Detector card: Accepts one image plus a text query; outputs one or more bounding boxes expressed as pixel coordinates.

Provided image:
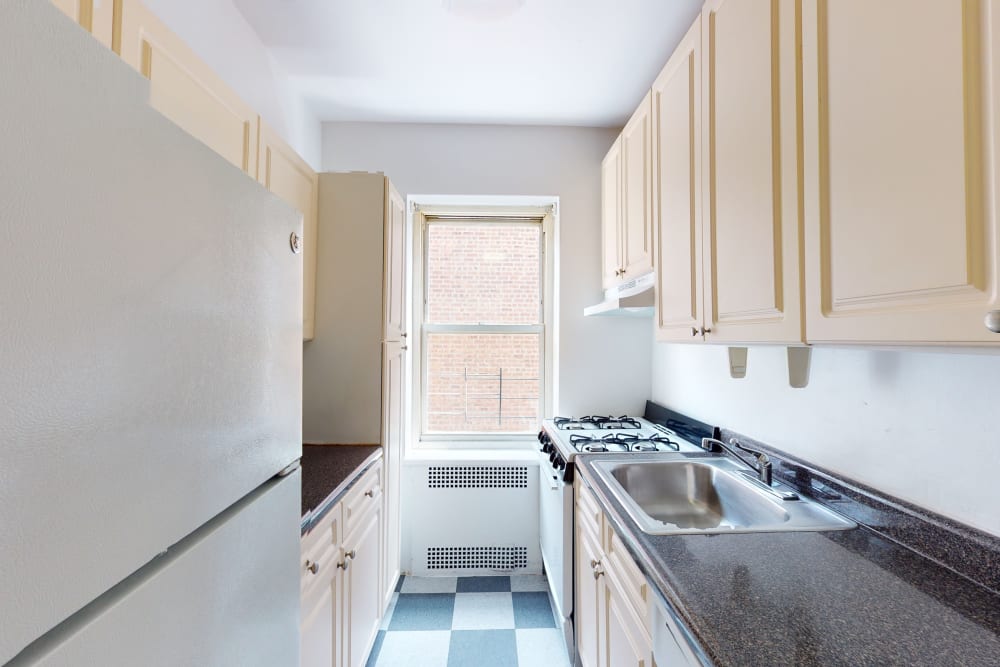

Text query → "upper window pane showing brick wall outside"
[427,222,541,324]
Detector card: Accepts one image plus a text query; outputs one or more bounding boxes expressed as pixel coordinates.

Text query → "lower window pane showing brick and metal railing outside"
[426,333,542,433]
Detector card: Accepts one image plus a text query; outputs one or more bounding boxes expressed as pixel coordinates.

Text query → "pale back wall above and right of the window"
[318,123,652,415]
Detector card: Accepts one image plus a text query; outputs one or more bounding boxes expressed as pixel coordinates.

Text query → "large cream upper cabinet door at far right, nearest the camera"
[802,0,1000,344]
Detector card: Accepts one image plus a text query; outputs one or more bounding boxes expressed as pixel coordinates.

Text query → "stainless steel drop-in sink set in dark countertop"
[593,455,857,535]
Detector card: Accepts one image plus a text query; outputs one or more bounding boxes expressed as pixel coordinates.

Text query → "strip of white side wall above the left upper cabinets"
[143,0,322,170]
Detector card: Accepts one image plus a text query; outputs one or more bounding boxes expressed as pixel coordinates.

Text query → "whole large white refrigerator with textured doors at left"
[0,0,309,667]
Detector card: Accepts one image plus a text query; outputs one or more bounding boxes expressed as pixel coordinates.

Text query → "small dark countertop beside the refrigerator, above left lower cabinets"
[302,445,382,533]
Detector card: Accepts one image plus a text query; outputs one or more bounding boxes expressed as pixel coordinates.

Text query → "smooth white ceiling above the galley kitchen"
[233,0,702,127]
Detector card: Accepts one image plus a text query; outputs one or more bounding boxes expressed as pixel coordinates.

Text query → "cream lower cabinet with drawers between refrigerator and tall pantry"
[301,466,385,667]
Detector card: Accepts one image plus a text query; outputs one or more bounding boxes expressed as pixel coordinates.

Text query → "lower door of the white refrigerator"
[8,472,301,667]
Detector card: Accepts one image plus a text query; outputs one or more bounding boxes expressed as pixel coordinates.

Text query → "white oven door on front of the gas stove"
[538,452,573,655]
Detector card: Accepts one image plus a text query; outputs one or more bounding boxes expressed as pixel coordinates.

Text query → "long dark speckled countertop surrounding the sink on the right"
[576,455,1000,667]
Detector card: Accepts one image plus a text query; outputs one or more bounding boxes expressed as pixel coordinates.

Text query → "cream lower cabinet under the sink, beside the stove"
[574,478,652,667]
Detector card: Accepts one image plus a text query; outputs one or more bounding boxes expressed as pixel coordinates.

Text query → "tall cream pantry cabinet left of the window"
[303,172,409,603]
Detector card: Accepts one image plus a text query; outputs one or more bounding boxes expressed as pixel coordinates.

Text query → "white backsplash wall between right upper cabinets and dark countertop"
[652,343,1000,535]
